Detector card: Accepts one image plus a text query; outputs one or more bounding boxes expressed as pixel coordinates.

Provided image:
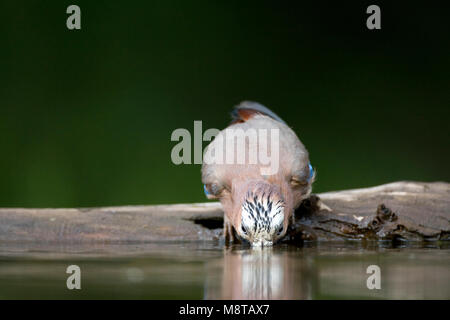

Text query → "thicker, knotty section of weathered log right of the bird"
[292,182,450,241]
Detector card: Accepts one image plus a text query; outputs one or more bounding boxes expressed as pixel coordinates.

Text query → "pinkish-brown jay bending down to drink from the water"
[201,101,316,247]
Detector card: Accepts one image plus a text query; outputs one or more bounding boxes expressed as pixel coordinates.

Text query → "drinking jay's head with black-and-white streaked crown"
[234,181,289,246]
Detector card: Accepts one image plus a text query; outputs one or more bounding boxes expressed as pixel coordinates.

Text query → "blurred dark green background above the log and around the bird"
[0,0,450,207]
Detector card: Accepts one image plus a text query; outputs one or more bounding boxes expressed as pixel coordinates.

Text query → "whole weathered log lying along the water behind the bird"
[0,182,450,242]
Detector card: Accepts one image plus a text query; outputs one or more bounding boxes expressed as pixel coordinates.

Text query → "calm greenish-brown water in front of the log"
[0,242,450,299]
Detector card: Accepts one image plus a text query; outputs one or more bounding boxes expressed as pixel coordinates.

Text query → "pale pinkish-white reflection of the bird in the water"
[205,248,317,300]
